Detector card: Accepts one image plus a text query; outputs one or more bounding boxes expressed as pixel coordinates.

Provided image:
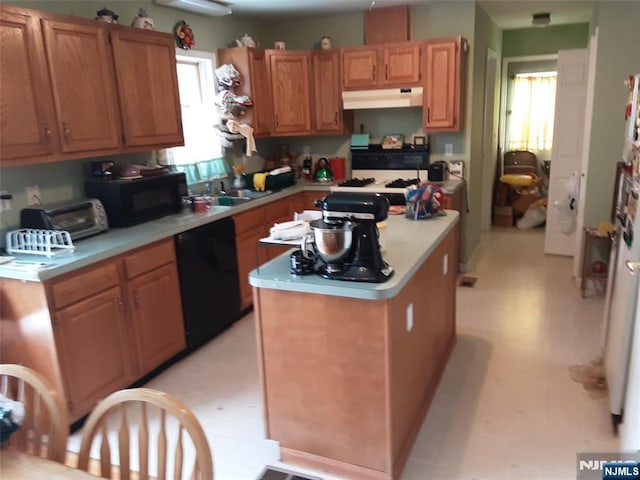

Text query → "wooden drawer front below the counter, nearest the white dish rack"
[50,262,120,310]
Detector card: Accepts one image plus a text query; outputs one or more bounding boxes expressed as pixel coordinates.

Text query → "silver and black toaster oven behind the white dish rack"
[20,198,109,240]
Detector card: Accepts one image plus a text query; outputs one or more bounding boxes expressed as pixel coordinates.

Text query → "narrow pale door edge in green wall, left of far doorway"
[480,48,498,232]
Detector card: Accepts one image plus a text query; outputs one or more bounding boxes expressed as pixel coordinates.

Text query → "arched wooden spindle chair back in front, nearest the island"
[78,388,213,480]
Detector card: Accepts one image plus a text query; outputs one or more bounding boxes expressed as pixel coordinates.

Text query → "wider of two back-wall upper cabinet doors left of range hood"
[268,50,311,135]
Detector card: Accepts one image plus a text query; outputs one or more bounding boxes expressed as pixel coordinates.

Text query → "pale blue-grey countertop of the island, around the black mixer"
[249,210,459,300]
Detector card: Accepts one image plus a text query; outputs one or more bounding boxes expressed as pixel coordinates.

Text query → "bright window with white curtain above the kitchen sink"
[162,51,227,183]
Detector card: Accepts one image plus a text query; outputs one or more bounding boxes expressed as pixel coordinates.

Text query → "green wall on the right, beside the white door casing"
[585,1,640,225]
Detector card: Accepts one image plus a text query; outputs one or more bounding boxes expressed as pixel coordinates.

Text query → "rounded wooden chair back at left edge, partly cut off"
[0,364,69,463]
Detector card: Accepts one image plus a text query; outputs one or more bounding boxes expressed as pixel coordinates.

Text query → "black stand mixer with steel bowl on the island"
[303,192,393,283]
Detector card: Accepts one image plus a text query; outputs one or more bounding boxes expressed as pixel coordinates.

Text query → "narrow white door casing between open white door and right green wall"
[573,27,598,278]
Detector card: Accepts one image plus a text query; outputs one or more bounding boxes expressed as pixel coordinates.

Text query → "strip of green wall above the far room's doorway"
[502,23,589,57]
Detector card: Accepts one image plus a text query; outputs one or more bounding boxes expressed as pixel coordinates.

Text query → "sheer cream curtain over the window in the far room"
[507,72,557,158]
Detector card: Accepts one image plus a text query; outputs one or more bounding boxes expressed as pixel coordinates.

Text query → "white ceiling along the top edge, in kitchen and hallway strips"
[218,0,595,29]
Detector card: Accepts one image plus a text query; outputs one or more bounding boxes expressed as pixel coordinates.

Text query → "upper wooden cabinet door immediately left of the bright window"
[111,29,184,146]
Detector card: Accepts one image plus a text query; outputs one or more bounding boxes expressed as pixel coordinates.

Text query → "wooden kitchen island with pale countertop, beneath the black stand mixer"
[249,210,459,479]
